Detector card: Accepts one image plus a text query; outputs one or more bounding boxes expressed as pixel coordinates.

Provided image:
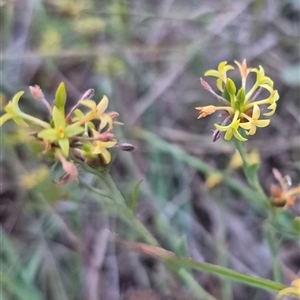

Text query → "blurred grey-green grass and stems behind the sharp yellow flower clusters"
[0,0,300,300]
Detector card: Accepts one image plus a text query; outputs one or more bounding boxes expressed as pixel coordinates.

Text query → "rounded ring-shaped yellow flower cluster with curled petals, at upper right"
[196,60,279,141]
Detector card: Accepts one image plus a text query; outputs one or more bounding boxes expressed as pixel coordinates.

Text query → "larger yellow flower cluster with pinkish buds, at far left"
[0,83,124,182]
